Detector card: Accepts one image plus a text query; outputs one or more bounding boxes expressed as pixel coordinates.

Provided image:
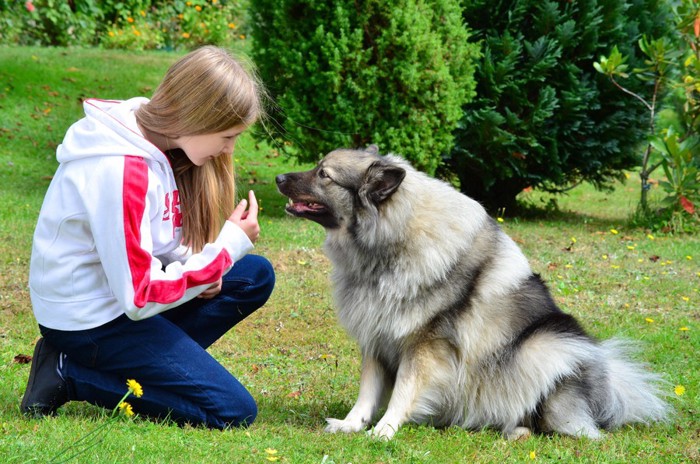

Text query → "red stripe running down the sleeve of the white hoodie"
[123,156,231,308]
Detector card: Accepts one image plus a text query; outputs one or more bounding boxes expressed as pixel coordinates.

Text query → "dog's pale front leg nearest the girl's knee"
[325,357,386,433]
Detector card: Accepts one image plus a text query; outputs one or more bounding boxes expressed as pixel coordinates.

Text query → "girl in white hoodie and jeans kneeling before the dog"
[21,47,274,429]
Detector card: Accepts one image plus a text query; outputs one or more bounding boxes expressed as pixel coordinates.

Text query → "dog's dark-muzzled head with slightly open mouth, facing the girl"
[276,145,406,229]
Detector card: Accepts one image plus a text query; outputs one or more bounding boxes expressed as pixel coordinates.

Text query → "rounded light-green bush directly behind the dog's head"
[250,0,478,172]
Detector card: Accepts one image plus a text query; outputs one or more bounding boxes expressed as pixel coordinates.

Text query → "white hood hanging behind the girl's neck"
[56,97,168,163]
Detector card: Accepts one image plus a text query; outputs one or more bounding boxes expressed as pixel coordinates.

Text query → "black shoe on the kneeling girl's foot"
[21,338,68,418]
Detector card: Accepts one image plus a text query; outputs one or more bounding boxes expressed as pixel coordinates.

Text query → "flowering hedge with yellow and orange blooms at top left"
[0,0,248,50]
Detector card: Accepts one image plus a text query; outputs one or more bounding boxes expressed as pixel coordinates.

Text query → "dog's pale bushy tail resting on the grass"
[598,339,671,429]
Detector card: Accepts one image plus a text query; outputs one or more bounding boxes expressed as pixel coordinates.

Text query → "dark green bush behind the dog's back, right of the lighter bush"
[448,0,670,210]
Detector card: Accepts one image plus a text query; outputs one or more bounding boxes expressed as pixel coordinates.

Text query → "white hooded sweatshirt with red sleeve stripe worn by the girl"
[29,98,253,330]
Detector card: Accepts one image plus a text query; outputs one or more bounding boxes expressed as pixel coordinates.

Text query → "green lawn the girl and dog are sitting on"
[0,47,700,463]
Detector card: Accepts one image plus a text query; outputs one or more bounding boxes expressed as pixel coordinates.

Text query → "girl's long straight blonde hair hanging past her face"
[136,46,263,252]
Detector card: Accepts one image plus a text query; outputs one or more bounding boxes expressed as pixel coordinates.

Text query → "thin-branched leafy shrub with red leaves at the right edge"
[594,0,700,232]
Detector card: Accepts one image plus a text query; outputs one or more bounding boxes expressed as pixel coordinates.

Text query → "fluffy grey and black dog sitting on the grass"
[277,146,669,439]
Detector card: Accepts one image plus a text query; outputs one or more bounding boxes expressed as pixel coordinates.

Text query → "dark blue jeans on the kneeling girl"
[39,255,275,429]
